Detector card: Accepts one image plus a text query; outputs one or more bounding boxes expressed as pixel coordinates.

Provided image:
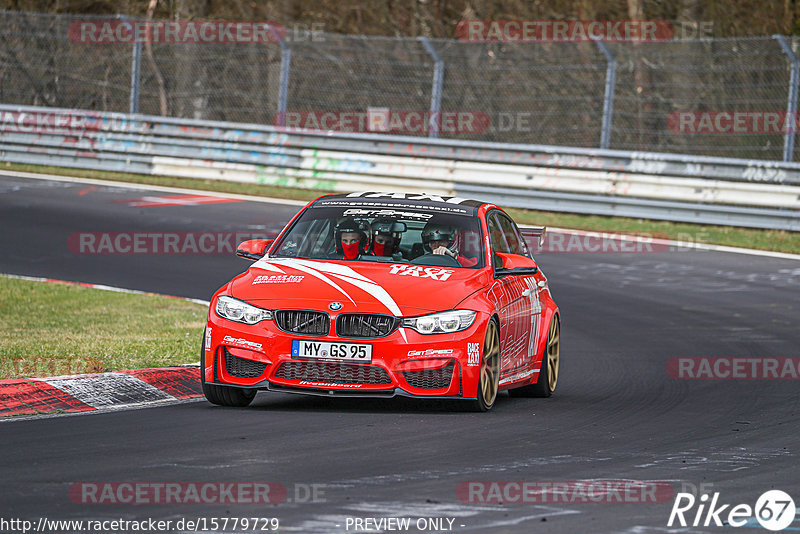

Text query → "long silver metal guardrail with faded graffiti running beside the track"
[0,105,800,231]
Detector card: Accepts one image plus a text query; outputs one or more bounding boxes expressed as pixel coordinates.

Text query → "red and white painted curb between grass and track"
[0,366,203,417]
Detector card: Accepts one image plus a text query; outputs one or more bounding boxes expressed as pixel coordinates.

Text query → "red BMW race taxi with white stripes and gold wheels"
[201,192,560,411]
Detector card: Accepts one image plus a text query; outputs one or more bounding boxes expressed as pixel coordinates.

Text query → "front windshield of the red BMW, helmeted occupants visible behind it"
[271,206,485,269]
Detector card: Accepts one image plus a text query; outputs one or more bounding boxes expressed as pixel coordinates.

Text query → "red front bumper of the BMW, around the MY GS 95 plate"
[202,311,486,398]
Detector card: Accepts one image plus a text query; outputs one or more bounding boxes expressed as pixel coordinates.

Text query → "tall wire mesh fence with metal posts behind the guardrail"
[0,11,800,161]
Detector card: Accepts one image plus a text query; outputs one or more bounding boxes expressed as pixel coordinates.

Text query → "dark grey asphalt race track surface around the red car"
[0,176,800,533]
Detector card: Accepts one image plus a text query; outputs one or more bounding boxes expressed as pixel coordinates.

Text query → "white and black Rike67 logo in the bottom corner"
[667,490,796,532]
